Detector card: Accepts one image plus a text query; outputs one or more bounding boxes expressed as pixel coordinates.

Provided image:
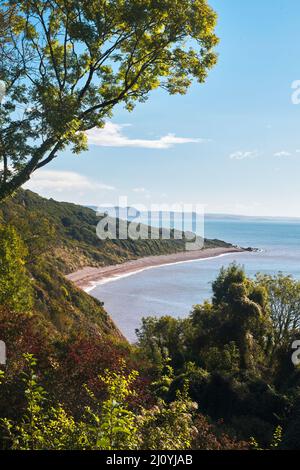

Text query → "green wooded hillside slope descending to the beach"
[0,190,232,337]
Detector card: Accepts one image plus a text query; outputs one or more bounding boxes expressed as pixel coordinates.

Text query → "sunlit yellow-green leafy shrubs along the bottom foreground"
[0,354,223,450]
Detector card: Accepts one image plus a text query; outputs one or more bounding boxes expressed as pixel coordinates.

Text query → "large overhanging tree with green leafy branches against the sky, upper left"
[0,0,218,200]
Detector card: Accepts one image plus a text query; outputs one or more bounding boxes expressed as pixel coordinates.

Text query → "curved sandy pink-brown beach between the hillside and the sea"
[66,247,245,292]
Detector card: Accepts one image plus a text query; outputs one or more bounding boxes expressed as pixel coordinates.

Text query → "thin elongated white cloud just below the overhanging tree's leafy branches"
[87,122,207,149]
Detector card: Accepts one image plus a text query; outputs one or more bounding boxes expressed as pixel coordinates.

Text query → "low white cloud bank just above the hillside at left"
[24,170,115,192]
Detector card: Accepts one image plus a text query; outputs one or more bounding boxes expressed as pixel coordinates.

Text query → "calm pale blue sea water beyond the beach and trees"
[91,218,300,341]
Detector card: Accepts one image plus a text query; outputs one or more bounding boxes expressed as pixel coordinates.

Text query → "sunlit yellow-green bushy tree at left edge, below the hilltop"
[0,225,32,312]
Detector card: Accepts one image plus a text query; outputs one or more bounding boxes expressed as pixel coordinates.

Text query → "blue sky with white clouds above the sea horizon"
[26,0,300,217]
